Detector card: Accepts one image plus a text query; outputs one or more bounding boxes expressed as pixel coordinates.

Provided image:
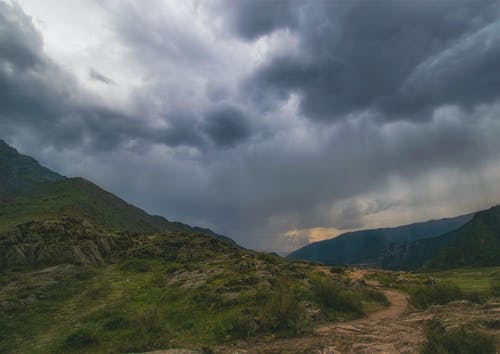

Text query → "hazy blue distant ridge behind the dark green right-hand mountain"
[288,215,472,266]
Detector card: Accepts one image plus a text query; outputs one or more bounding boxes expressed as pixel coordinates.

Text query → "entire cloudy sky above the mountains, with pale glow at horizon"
[0,0,500,252]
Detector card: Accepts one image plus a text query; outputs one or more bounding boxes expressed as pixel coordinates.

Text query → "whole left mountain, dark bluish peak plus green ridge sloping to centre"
[0,142,234,242]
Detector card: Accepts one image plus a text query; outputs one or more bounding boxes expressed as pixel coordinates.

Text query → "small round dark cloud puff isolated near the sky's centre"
[205,106,251,148]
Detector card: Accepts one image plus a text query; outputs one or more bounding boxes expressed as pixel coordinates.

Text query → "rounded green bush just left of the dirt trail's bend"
[311,279,363,315]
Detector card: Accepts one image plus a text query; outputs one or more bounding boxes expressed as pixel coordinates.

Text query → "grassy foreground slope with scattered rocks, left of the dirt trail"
[0,223,386,353]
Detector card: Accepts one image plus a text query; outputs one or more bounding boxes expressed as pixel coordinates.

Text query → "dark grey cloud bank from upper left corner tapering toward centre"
[0,2,209,152]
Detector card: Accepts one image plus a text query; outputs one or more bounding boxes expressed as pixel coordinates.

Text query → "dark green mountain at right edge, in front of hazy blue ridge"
[382,206,500,269]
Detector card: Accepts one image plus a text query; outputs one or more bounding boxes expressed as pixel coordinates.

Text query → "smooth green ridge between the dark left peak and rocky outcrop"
[0,178,232,242]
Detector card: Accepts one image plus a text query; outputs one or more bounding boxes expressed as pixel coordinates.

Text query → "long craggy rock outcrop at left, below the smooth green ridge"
[0,217,238,269]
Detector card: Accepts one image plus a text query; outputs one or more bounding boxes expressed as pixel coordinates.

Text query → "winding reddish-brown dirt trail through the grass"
[215,269,424,354]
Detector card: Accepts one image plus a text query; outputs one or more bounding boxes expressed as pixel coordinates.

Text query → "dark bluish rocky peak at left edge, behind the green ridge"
[0,139,64,199]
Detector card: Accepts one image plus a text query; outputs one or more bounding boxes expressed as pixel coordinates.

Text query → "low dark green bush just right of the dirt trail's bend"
[409,283,465,309]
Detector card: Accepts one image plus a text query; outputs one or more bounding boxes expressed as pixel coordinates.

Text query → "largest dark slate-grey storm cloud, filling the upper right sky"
[240,0,500,121]
